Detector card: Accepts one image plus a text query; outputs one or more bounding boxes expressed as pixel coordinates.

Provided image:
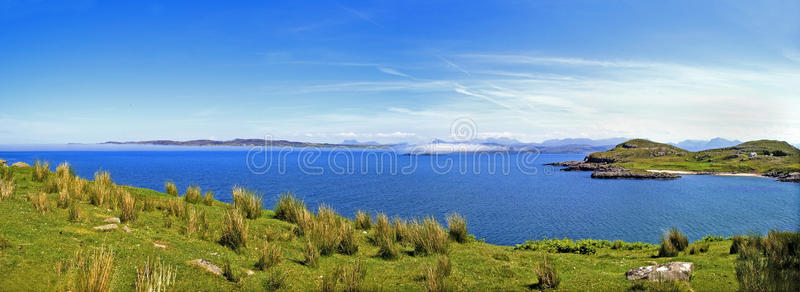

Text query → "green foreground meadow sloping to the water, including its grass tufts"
[0,164,798,291]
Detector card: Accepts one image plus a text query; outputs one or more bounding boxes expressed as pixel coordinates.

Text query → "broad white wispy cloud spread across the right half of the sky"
[274,54,800,141]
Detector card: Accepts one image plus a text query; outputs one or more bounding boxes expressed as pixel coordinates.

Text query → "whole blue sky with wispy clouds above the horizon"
[0,0,800,144]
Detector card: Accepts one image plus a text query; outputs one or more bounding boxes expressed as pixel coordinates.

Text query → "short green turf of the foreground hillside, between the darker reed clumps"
[0,166,768,291]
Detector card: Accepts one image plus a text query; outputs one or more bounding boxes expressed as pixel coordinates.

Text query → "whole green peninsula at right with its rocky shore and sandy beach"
[549,139,800,182]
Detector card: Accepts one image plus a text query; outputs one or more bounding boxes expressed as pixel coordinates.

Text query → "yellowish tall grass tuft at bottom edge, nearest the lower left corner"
[75,247,114,292]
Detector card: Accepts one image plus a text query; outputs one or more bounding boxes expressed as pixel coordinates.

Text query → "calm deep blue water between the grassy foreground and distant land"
[0,147,800,245]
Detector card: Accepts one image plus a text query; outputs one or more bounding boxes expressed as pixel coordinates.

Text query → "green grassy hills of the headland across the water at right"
[587,139,800,173]
